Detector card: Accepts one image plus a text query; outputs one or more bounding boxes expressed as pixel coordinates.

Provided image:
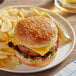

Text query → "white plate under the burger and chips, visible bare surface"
[0,6,75,73]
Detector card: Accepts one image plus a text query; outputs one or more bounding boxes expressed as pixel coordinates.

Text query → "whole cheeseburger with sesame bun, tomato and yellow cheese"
[9,16,59,67]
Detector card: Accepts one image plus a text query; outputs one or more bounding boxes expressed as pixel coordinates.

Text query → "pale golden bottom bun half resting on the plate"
[15,51,56,67]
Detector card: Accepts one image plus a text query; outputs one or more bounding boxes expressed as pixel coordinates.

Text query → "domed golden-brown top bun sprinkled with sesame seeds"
[14,16,58,48]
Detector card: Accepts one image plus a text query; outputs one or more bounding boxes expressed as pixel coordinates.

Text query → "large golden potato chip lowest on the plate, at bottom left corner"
[0,56,20,69]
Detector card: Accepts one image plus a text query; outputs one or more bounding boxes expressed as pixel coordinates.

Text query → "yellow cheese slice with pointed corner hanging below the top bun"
[29,40,57,56]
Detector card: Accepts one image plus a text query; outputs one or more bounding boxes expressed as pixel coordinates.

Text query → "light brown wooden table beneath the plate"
[0,0,76,76]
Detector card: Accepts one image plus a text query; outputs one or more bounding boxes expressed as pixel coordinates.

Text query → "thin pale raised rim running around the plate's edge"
[0,5,75,73]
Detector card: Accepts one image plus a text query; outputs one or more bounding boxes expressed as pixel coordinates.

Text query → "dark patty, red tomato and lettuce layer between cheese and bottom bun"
[8,40,59,59]
